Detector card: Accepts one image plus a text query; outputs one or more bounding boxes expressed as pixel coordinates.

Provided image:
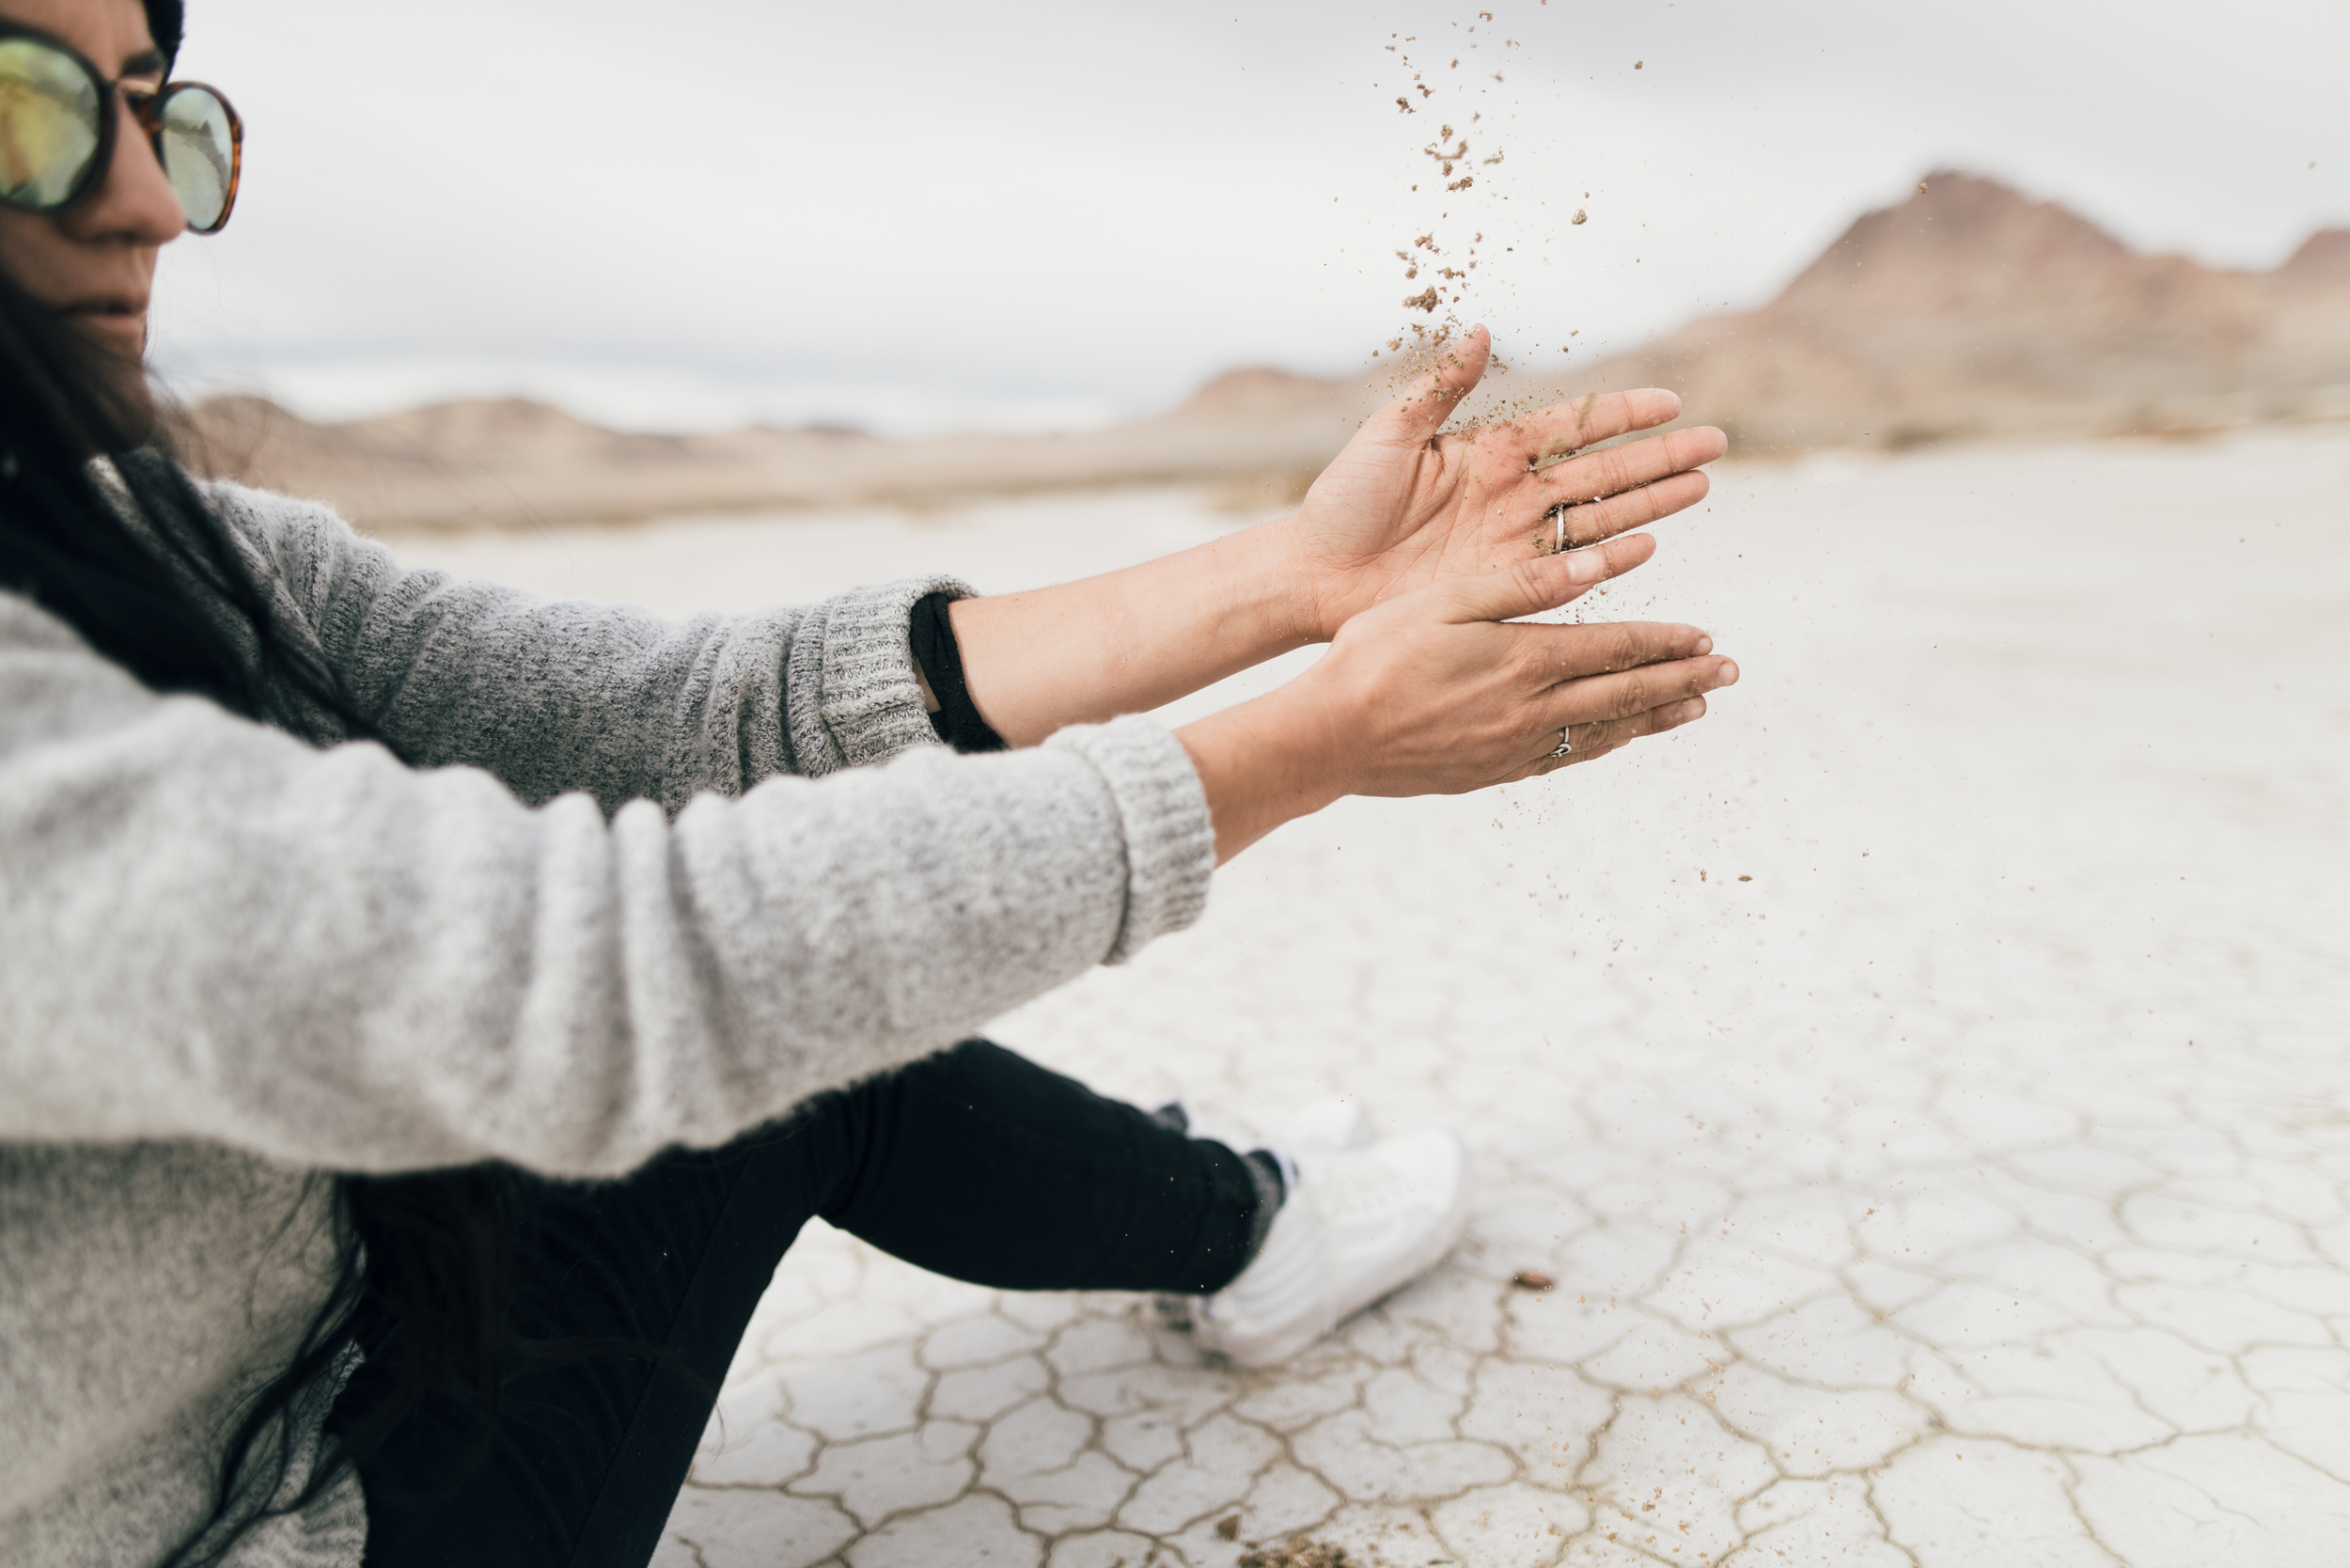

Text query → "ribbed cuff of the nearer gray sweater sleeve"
[1046,717,1215,964]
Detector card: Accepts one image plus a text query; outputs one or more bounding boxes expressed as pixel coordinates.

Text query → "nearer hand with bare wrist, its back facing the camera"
[1178,534,1739,860]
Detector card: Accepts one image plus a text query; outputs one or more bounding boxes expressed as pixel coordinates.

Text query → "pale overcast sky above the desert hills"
[155,0,2350,431]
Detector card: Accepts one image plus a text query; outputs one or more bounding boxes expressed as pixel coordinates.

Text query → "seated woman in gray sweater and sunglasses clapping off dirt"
[0,0,1737,1568]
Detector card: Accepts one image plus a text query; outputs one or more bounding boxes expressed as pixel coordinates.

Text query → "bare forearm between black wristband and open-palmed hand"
[948,520,1316,752]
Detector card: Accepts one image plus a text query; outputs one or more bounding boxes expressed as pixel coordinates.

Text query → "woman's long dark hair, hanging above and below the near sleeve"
[0,0,545,1563]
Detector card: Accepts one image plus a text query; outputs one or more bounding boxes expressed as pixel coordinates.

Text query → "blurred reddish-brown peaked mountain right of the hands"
[1591,172,2350,456]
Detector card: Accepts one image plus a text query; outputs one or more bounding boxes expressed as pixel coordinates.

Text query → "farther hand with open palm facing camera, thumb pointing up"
[1281,327,1730,639]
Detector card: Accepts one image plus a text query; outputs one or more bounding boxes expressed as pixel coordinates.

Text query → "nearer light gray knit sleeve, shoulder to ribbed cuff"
[0,595,1213,1175]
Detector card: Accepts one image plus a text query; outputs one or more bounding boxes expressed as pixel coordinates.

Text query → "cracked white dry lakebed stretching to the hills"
[395,431,2350,1568]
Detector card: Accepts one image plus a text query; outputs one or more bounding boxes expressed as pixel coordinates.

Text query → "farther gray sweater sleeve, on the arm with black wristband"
[205,484,971,813]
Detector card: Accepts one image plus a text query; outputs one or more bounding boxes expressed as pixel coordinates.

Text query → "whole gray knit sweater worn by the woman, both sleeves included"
[0,487,1213,1568]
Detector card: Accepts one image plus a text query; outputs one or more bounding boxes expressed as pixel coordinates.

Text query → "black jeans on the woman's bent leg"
[337,1039,1262,1568]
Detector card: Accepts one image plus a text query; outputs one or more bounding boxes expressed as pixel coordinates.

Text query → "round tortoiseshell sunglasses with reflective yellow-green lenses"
[0,24,244,235]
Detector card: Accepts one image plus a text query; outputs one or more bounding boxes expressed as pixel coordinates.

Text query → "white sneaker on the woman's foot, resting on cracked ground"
[1192,1128,1469,1366]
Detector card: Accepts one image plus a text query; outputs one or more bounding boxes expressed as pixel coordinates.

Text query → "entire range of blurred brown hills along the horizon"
[186,172,2350,529]
